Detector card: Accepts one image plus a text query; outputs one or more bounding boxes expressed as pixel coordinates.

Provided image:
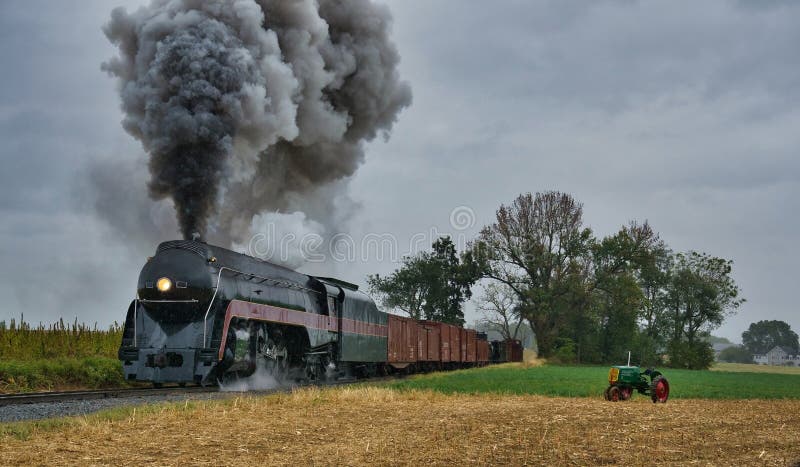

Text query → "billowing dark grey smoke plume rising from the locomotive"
[103,0,411,244]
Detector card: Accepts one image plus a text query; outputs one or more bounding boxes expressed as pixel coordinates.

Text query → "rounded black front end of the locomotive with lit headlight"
[119,241,216,385]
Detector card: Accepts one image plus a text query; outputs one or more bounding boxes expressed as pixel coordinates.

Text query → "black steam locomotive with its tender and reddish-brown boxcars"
[119,240,491,385]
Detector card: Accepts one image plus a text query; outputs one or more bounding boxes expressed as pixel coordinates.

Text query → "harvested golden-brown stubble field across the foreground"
[0,388,800,466]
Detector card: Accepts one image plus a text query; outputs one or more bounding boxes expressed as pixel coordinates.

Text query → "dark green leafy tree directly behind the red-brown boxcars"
[367,237,476,326]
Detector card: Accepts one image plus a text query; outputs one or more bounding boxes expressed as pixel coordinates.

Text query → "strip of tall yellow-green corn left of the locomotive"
[0,317,122,361]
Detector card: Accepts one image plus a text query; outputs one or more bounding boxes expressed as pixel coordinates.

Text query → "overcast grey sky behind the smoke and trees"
[0,0,800,341]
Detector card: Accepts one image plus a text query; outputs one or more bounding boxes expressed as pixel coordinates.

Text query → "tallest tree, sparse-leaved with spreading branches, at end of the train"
[466,191,592,356]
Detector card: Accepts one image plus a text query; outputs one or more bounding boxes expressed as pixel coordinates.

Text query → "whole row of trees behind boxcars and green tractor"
[367,191,744,368]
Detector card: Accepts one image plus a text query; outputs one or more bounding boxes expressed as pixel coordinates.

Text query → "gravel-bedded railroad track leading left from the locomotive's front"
[0,386,219,407]
